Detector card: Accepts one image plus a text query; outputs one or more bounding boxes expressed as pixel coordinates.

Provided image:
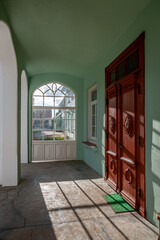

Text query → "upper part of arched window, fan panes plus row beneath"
[33,83,75,108]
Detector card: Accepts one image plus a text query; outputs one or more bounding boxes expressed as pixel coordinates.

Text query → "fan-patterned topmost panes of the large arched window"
[33,83,75,97]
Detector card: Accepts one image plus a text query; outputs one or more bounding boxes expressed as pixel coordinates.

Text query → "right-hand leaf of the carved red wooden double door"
[118,75,138,209]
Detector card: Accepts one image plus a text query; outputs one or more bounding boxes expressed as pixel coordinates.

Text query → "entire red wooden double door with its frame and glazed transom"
[105,34,145,216]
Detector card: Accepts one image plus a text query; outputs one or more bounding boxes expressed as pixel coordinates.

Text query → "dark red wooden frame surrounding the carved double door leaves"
[105,32,146,217]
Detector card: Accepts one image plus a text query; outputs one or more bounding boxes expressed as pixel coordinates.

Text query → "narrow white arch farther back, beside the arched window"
[21,70,28,163]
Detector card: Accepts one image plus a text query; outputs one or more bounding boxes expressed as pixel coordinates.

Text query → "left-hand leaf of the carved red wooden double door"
[106,86,117,190]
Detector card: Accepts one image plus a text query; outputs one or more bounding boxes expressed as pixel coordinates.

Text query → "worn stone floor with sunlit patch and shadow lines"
[0,161,158,240]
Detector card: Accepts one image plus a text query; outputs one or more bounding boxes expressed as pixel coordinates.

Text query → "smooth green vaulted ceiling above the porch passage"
[3,0,150,77]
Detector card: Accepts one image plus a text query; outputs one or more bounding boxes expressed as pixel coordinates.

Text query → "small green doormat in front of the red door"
[104,194,135,213]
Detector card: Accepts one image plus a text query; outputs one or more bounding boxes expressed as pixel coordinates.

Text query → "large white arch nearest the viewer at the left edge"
[0,21,18,186]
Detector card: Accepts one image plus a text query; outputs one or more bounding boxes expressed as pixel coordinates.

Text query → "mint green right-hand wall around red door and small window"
[84,0,160,225]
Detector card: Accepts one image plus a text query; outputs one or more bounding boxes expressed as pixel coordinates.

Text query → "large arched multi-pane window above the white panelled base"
[32,83,76,141]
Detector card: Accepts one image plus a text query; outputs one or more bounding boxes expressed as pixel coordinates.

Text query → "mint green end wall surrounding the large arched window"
[28,73,84,162]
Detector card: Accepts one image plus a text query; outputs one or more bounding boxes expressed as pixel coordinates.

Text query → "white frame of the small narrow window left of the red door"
[88,84,97,144]
